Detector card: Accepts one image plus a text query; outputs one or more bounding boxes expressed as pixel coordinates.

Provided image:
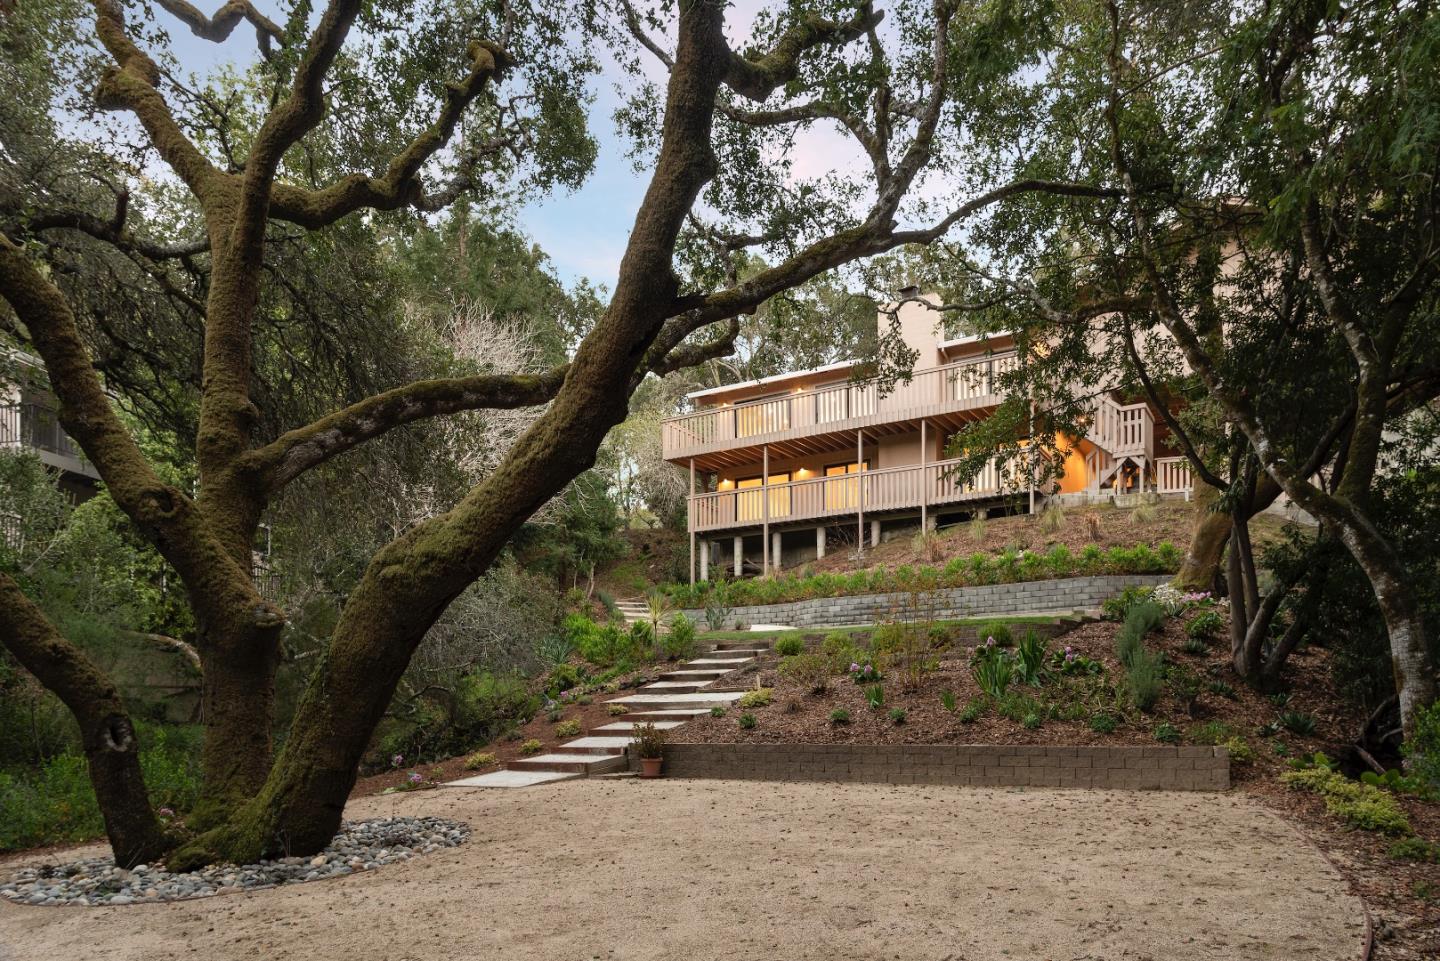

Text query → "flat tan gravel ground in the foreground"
[0,779,1364,961]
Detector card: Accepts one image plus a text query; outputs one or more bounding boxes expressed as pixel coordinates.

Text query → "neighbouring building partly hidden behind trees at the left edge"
[0,347,99,503]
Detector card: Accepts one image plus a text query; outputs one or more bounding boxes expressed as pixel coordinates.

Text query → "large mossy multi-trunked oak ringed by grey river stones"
[0,0,1096,869]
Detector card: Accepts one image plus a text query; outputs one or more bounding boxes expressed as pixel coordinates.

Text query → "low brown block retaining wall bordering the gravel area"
[653,743,1230,791]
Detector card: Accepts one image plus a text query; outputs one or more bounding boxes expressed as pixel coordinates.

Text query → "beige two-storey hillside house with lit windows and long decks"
[661,288,1191,581]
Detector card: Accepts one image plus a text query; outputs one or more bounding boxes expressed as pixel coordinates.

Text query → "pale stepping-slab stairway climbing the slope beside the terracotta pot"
[444,637,770,788]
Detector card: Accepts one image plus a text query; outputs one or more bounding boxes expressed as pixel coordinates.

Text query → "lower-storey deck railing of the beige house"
[690,458,1024,532]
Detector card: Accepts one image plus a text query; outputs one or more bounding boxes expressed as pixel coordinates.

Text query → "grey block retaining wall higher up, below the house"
[684,573,1171,627]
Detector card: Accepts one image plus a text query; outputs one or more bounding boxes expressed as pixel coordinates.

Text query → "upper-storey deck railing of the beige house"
[661,352,1020,457]
